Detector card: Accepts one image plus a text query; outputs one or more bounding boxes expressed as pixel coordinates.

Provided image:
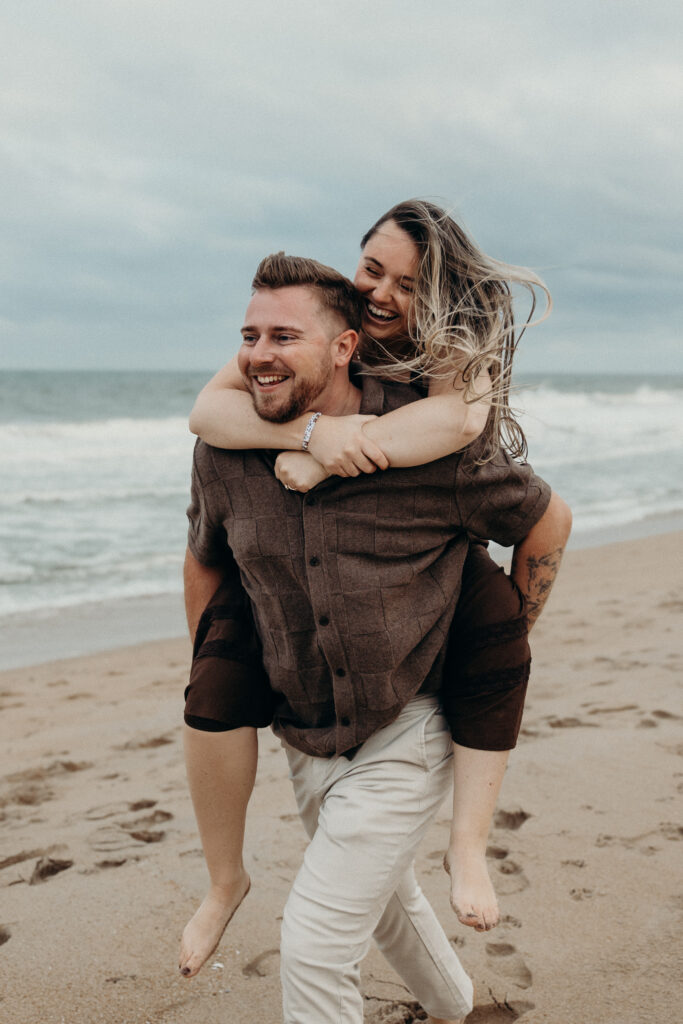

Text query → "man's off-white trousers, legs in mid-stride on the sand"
[281,696,472,1024]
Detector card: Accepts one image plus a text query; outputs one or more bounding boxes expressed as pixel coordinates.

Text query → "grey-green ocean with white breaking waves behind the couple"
[0,371,683,622]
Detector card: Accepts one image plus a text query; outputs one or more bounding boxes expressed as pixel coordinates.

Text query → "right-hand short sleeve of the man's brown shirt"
[456,450,551,547]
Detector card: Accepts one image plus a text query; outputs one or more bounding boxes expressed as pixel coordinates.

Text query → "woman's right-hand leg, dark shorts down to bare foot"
[442,544,530,931]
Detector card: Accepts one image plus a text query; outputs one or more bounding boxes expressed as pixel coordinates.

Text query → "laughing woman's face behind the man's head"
[353,220,420,342]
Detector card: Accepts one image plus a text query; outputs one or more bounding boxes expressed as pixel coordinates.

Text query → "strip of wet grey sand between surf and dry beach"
[0,514,683,671]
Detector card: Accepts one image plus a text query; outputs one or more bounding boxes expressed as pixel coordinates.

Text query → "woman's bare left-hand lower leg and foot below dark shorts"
[178,725,258,978]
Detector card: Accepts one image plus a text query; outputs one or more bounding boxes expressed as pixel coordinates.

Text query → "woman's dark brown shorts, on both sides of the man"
[185,544,530,751]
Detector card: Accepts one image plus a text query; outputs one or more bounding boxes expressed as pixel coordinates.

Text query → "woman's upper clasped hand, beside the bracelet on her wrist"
[305,415,389,477]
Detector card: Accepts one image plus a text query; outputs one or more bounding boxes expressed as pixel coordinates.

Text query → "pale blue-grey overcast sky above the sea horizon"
[0,0,683,373]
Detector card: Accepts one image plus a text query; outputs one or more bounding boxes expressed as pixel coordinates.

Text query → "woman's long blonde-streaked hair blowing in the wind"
[360,200,552,461]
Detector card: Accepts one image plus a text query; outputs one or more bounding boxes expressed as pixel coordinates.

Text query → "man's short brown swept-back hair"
[252,252,362,331]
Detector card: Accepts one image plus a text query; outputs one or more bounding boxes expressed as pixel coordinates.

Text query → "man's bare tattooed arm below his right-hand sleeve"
[510,492,571,629]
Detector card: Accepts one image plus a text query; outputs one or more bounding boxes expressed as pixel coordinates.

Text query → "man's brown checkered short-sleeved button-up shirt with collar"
[187,377,550,757]
